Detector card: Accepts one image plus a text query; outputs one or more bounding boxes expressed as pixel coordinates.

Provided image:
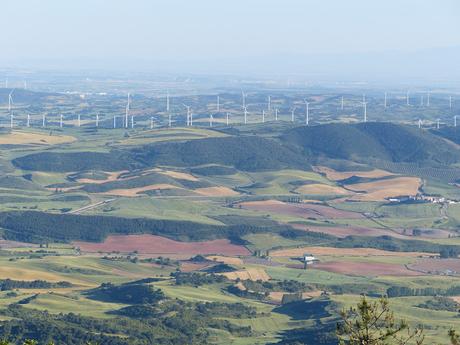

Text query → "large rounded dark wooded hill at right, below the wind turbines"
[282,122,460,165]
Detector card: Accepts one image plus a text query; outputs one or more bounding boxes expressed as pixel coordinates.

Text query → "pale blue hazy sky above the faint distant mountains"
[0,0,460,77]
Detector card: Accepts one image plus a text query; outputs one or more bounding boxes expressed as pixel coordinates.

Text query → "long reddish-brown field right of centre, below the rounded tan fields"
[239,200,364,219]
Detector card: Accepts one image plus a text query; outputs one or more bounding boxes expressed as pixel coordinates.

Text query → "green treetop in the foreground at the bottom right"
[337,297,424,345]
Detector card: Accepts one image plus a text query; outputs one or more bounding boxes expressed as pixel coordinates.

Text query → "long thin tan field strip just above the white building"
[270,247,433,258]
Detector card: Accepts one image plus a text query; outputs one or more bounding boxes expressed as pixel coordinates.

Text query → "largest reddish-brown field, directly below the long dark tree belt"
[73,235,250,256]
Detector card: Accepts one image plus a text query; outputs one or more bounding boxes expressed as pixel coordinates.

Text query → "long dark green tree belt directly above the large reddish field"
[0,211,289,243]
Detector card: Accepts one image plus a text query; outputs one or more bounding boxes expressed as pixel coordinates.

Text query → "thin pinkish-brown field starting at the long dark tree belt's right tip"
[291,224,407,239]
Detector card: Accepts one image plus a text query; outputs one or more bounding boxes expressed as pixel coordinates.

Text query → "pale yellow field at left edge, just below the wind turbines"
[0,131,77,145]
